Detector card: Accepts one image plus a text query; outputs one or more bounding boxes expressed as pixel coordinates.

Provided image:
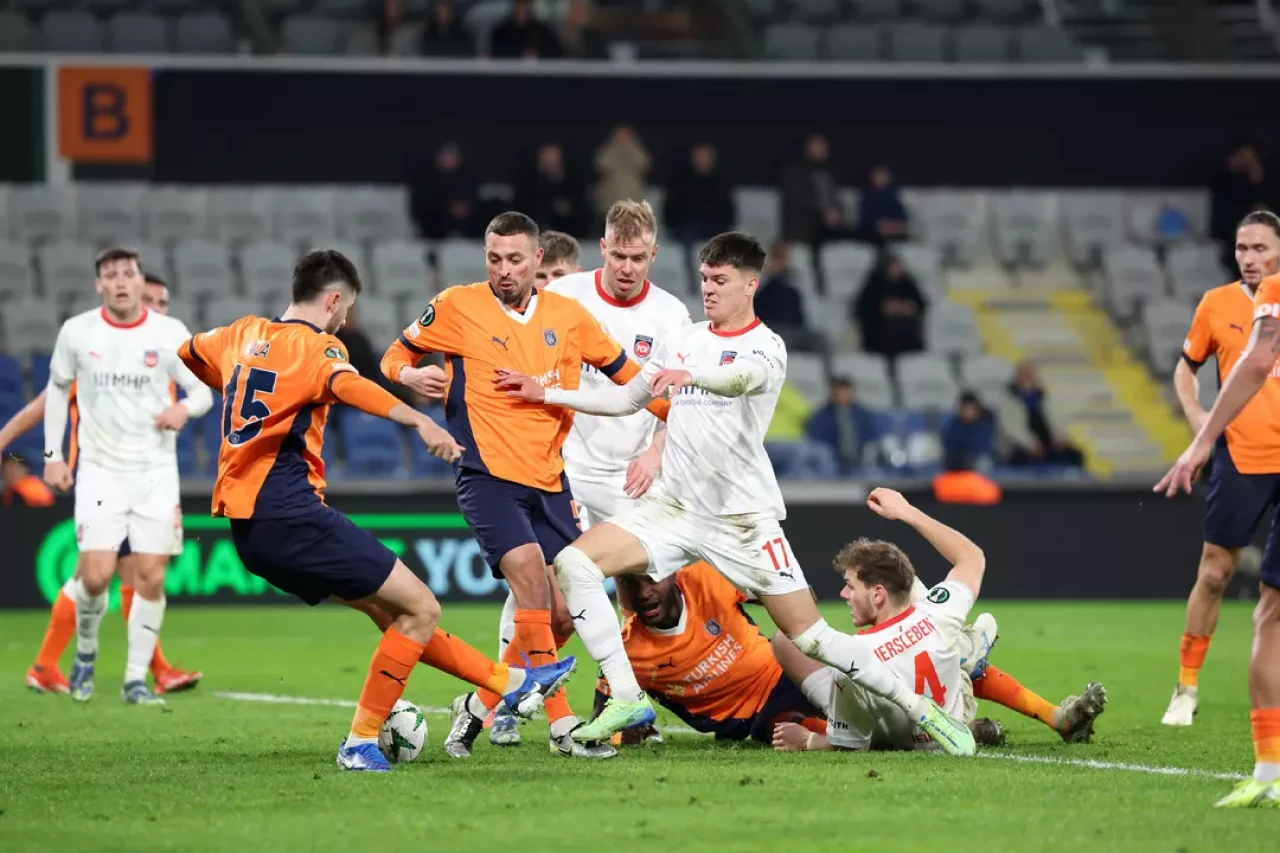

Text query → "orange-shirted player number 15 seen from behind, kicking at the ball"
[179,250,573,772]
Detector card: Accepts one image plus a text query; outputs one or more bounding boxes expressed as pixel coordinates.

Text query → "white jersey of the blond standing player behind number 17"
[545,270,692,484]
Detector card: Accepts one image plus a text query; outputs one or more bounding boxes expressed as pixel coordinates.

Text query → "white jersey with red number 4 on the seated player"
[827,580,974,749]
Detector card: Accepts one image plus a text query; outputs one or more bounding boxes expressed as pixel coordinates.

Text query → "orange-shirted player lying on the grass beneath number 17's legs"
[595,562,1101,745]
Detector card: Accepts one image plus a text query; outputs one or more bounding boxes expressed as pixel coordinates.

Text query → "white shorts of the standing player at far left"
[76,462,182,556]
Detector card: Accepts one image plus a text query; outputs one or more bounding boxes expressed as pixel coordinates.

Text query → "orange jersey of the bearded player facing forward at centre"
[373,282,640,492]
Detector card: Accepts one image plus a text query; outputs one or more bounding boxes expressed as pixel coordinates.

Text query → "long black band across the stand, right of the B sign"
[154,68,1280,187]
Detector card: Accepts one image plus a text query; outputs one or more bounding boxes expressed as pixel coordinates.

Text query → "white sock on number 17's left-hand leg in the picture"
[556,546,644,702]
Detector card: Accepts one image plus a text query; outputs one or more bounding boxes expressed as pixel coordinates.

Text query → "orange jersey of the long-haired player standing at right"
[1183,279,1280,474]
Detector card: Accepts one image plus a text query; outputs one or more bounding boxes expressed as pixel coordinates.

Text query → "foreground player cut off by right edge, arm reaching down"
[1153,263,1280,808]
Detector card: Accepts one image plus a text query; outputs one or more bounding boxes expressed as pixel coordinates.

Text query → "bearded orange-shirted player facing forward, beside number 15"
[381,213,666,758]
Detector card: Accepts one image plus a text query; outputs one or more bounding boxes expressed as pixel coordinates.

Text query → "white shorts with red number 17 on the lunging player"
[609,496,809,597]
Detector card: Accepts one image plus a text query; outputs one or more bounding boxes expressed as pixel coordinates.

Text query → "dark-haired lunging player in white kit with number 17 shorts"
[499,232,974,756]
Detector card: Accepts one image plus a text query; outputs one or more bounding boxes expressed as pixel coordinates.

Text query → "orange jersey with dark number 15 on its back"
[178,316,357,519]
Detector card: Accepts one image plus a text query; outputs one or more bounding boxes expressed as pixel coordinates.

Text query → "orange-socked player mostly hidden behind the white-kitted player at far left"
[11,274,204,694]
